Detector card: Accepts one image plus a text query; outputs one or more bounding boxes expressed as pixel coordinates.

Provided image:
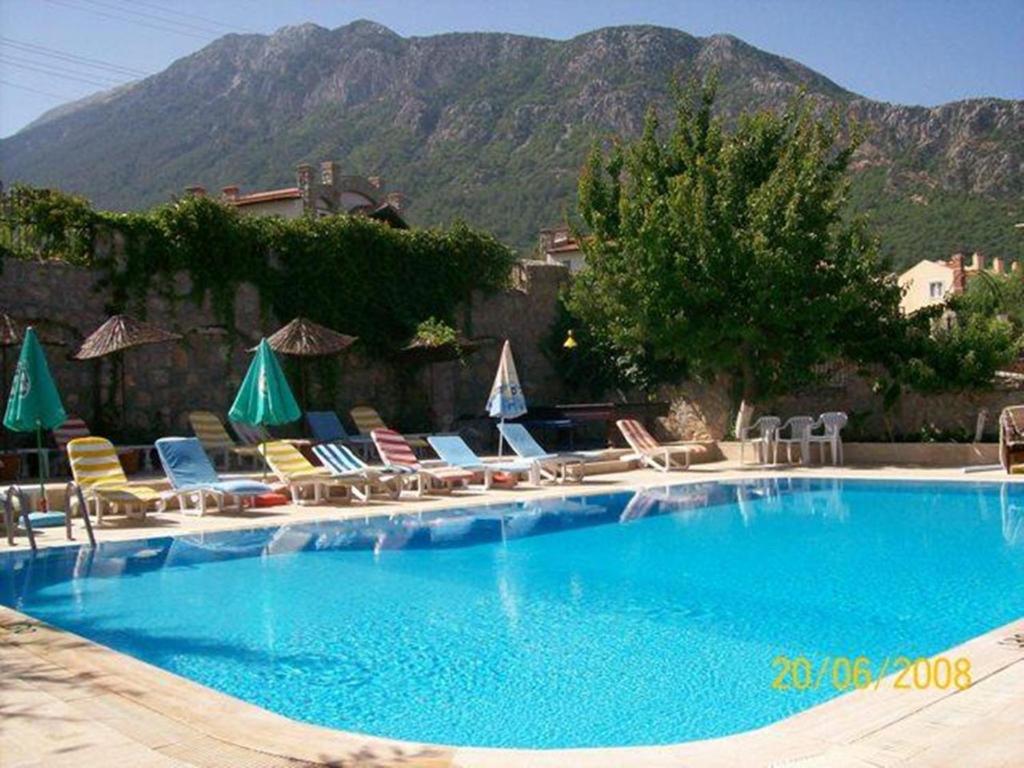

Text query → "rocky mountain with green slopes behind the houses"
[0,22,1024,263]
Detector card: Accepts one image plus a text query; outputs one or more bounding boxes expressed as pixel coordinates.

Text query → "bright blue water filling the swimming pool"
[0,479,1024,748]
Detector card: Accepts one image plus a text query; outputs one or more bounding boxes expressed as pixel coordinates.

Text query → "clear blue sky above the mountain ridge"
[0,0,1024,136]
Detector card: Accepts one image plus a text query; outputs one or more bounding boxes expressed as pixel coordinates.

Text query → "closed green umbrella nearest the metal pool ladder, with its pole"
[3,328,68,510]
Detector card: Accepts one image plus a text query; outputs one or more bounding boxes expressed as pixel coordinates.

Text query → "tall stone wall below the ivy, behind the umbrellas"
[0,259,567,439]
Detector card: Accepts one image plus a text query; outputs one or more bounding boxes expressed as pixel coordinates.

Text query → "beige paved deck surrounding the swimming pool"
[0,462,1024,768]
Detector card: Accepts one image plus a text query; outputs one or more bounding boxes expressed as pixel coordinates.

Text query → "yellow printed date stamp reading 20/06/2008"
[771,655,972,692]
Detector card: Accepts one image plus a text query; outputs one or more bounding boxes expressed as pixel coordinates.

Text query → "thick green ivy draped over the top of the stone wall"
[0,185,514,356]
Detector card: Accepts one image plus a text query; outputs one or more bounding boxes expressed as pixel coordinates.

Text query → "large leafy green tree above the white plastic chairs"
[568,82,903,402]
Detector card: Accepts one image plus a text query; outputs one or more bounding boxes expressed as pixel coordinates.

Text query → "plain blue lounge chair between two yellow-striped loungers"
[157,437,272,515]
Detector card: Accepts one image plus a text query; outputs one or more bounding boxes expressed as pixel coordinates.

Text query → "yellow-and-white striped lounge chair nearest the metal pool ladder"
[68,437,164,523]
